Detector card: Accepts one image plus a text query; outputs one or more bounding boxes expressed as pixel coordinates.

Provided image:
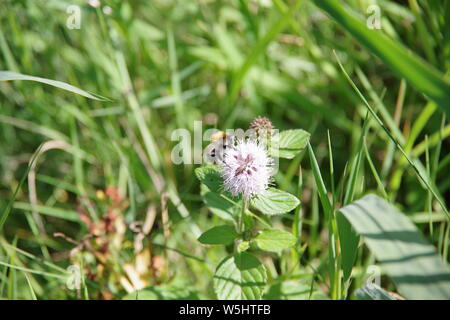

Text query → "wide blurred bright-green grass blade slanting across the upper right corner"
[314,0,450,115]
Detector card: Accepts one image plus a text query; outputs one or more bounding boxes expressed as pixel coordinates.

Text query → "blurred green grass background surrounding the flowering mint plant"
[0,0,450,299]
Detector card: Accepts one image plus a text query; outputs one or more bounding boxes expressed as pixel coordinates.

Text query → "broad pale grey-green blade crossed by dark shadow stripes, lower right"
[340,195,450,299]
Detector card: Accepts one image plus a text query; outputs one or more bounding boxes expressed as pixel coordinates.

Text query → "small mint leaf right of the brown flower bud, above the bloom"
[270,129,310,159]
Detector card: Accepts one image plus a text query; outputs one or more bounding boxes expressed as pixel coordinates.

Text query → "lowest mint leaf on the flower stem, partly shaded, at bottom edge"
[214,252,267,300]
